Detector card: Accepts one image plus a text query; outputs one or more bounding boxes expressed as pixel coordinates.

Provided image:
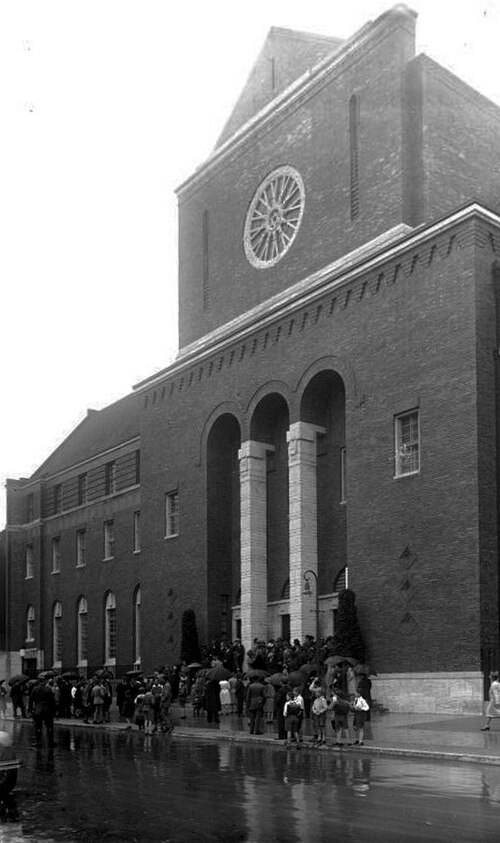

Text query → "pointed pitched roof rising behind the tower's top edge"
[216,27,343,149]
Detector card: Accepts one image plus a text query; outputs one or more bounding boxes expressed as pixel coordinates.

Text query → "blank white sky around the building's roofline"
[0,0,500,528]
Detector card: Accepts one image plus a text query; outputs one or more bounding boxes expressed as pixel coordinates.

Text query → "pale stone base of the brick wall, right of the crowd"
[372,671,483,714]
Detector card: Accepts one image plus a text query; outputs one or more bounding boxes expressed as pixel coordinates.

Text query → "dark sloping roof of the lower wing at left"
[32,393,141,479]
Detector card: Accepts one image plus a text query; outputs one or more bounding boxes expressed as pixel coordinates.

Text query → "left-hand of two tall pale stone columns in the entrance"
[238,440,271,651]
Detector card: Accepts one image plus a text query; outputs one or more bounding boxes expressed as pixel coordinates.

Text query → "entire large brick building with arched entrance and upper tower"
[2,6,500,711]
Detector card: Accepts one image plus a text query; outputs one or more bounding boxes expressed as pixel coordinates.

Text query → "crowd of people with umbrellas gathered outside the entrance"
[0,636,371,746]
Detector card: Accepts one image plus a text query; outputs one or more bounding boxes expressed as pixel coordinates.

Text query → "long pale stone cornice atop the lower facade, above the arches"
[134,203,500,393]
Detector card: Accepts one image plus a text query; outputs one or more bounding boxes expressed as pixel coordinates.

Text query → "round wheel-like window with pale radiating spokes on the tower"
[243,166,305,269]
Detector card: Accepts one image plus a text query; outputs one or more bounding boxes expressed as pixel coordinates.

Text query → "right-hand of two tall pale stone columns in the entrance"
[287,422,324,641]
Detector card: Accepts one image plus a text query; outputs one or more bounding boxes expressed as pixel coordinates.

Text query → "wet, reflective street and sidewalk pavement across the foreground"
[0,710,500,843]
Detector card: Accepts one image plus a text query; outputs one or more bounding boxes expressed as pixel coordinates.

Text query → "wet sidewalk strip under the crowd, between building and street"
[24,705,500,766]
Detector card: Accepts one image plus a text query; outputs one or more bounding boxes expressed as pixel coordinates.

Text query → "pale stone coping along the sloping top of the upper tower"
[176,4,416,199]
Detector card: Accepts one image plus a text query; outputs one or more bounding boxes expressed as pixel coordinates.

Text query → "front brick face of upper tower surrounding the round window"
[179,16,414,347]
